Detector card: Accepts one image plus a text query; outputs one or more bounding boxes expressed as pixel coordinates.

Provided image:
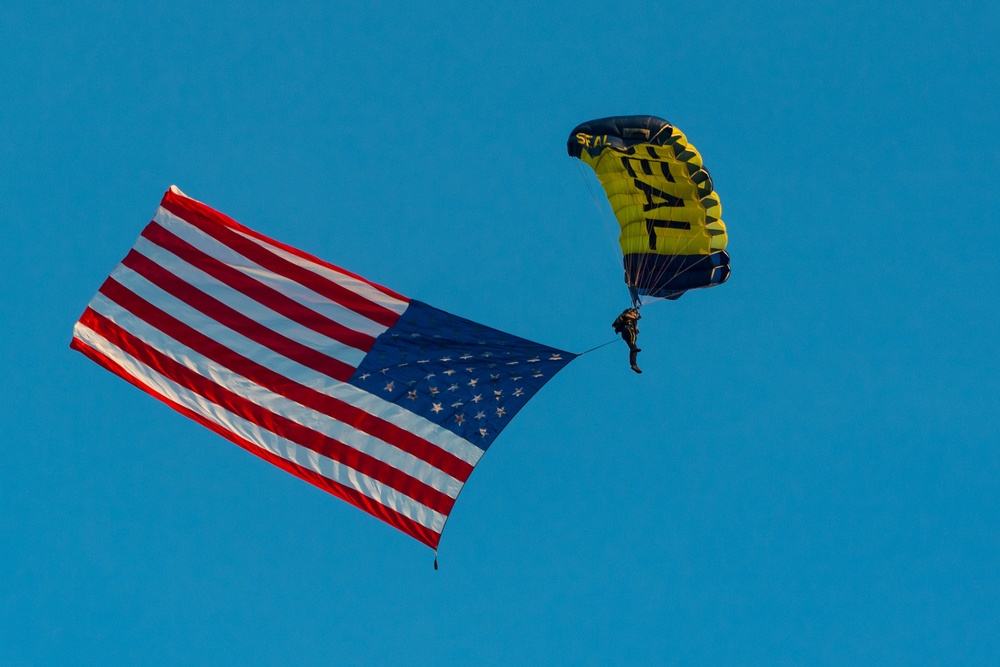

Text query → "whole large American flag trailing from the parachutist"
[71,187,577,549]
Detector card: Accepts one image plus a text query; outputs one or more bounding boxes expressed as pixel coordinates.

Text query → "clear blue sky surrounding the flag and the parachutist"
[0,0,1000,666]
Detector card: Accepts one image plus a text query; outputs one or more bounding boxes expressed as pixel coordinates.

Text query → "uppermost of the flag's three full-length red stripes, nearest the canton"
[100,277,472,482]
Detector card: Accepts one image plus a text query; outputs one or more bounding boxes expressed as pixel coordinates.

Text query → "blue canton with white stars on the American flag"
[348,301,577,450]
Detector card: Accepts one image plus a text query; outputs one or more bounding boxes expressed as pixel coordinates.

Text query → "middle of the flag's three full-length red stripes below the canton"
[80,308,455,515]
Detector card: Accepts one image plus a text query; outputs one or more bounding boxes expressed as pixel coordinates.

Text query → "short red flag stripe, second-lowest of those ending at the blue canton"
[142,222,376,352]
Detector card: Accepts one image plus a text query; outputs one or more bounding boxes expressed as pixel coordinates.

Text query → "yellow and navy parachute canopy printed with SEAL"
[566,116,729,306]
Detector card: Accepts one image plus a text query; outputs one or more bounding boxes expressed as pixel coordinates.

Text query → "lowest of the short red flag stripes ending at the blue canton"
[122,250,355,381]
